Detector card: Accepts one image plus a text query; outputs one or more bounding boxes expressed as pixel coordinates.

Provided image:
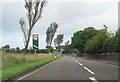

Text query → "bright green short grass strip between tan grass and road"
[2,55,61,80]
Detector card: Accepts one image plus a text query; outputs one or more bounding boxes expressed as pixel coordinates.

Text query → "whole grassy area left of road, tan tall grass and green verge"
[2,54,61,79]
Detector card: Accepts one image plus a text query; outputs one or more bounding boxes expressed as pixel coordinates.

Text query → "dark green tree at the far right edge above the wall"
[99,25,120,53]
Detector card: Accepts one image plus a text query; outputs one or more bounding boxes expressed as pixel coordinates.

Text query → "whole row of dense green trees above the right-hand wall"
[69,25,120,53]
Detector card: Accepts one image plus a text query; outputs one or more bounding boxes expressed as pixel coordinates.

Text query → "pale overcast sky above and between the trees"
[0,0,119,48]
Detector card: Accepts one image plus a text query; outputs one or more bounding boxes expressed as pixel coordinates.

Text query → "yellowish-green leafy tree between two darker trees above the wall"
[84,29,108,53]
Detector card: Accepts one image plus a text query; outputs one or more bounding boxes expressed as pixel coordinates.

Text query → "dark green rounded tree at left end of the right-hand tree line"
[72,27,98,53]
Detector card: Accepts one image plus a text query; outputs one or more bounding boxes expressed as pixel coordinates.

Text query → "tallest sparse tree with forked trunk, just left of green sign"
[19,0,47,49]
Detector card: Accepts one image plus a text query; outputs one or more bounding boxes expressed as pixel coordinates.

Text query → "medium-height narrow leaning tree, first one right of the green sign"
[46,22,58,52]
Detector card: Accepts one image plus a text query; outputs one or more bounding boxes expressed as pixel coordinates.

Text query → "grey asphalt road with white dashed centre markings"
[14,56,118,82]
